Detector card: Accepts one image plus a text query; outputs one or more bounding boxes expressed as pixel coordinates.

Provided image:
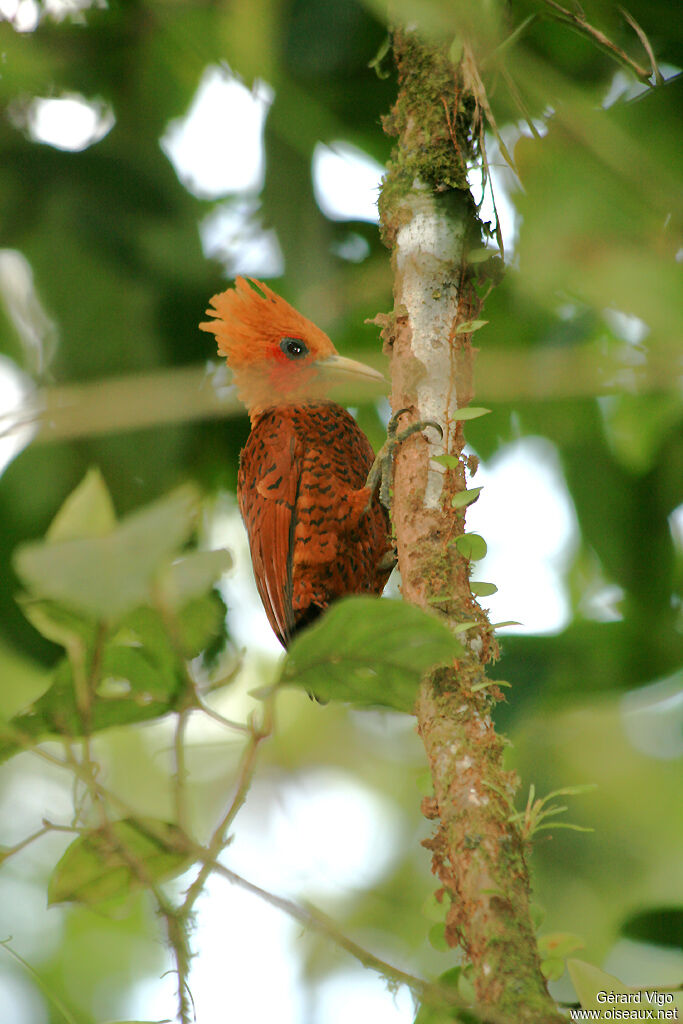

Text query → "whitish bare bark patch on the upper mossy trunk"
[394,189,466,508]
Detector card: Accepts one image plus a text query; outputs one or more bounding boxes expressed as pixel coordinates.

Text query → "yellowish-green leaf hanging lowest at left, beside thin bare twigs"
[47,818,191,906]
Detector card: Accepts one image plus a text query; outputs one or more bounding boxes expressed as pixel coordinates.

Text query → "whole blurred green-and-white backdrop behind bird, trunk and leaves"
[0,0,683,1024]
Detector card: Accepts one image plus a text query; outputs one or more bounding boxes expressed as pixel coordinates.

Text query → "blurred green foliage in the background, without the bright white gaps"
[0,0,683,1021]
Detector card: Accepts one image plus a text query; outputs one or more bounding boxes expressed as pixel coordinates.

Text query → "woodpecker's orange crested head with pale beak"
[200,278,384,419]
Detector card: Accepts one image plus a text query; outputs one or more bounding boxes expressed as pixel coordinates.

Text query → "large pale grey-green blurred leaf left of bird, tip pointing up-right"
[14,485,198,620]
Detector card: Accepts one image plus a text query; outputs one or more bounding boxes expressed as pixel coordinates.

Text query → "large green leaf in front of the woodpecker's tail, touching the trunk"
[280,597,463,713]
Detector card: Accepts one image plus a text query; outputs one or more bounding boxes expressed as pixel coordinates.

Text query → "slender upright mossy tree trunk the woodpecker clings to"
[380,30,564,1022]
